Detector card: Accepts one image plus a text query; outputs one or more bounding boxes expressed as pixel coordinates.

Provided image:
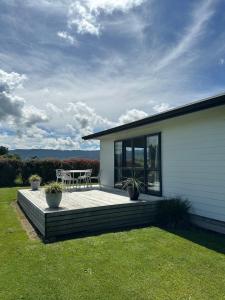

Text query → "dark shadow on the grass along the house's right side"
[162,226,225,254]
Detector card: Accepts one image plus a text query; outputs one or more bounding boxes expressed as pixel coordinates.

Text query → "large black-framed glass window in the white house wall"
[115,134,162,195]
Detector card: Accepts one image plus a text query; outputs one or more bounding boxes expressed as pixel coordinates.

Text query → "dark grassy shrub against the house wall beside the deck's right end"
[156,198,191,227]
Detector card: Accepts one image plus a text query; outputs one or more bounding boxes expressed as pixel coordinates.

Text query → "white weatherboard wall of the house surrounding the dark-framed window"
[101,106,225,221]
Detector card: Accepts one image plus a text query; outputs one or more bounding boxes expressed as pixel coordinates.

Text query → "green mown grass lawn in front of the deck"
[0,188,225,300]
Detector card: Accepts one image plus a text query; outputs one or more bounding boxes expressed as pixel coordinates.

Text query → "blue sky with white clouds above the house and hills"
[0,0,225,150]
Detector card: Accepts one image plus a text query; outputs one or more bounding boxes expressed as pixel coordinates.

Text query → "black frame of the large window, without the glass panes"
[114,132,162,197]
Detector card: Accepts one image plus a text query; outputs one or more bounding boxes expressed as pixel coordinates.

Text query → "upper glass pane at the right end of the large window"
[147,135,160,170]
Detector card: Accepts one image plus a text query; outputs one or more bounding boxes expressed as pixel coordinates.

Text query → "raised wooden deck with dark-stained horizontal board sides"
[17,188,159,239]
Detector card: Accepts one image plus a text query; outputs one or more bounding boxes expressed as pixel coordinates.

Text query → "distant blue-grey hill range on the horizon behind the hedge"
[9,149,99,160]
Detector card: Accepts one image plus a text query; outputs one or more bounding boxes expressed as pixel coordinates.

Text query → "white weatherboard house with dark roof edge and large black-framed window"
[83,94,225,233]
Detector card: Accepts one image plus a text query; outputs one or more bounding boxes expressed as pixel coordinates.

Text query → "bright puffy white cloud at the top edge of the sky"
[68,0,145,36]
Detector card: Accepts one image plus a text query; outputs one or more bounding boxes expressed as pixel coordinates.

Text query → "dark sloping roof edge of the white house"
[83,94,225,140]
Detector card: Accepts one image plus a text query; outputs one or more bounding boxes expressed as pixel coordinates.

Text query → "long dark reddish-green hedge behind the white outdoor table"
[0,159,99,187]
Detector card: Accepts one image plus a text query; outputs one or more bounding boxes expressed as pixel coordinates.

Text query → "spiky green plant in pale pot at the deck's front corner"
[45,182,62,208]
